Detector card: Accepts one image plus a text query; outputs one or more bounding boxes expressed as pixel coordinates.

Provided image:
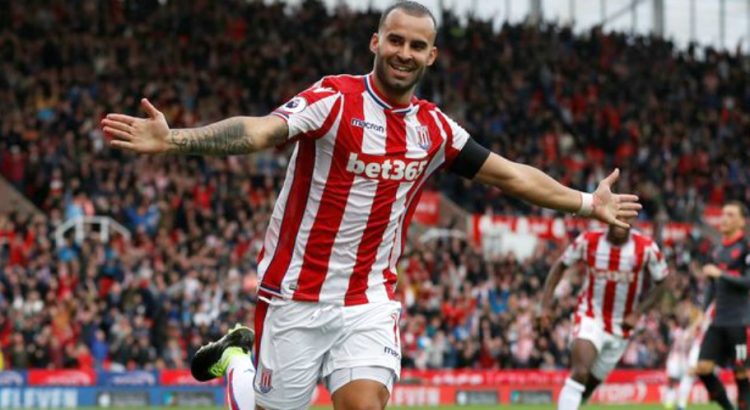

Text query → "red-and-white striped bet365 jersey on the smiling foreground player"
[258,74,469,305]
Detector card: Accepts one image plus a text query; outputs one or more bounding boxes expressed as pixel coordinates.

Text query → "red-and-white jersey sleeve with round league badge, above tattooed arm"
[271,81,341,139]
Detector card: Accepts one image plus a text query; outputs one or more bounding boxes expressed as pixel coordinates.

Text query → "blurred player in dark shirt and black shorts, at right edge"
[696,201,750,410]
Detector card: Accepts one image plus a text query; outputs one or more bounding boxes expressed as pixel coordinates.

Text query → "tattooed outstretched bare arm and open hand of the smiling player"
[102,98,289,155]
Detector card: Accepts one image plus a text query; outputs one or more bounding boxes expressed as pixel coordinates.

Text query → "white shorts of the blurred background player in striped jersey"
[573,316,628,381]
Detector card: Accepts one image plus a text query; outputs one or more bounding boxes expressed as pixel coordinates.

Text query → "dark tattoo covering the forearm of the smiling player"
[168,118,256,155]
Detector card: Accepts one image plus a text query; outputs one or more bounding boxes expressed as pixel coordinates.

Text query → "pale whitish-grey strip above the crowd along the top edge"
[302,0,750,51]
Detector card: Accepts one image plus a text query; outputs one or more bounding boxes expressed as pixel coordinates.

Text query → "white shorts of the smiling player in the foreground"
[253,300,401,410]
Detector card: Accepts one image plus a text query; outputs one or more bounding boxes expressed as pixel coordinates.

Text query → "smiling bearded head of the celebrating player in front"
[370,9,437,94]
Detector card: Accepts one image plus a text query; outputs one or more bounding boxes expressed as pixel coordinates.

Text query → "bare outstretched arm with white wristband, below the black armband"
[475,153,641,228]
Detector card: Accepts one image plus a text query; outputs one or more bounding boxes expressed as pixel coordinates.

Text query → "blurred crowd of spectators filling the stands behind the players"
[0,0,750,368]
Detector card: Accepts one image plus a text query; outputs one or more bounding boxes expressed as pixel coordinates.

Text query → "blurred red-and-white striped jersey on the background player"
[562,230,669,337]
